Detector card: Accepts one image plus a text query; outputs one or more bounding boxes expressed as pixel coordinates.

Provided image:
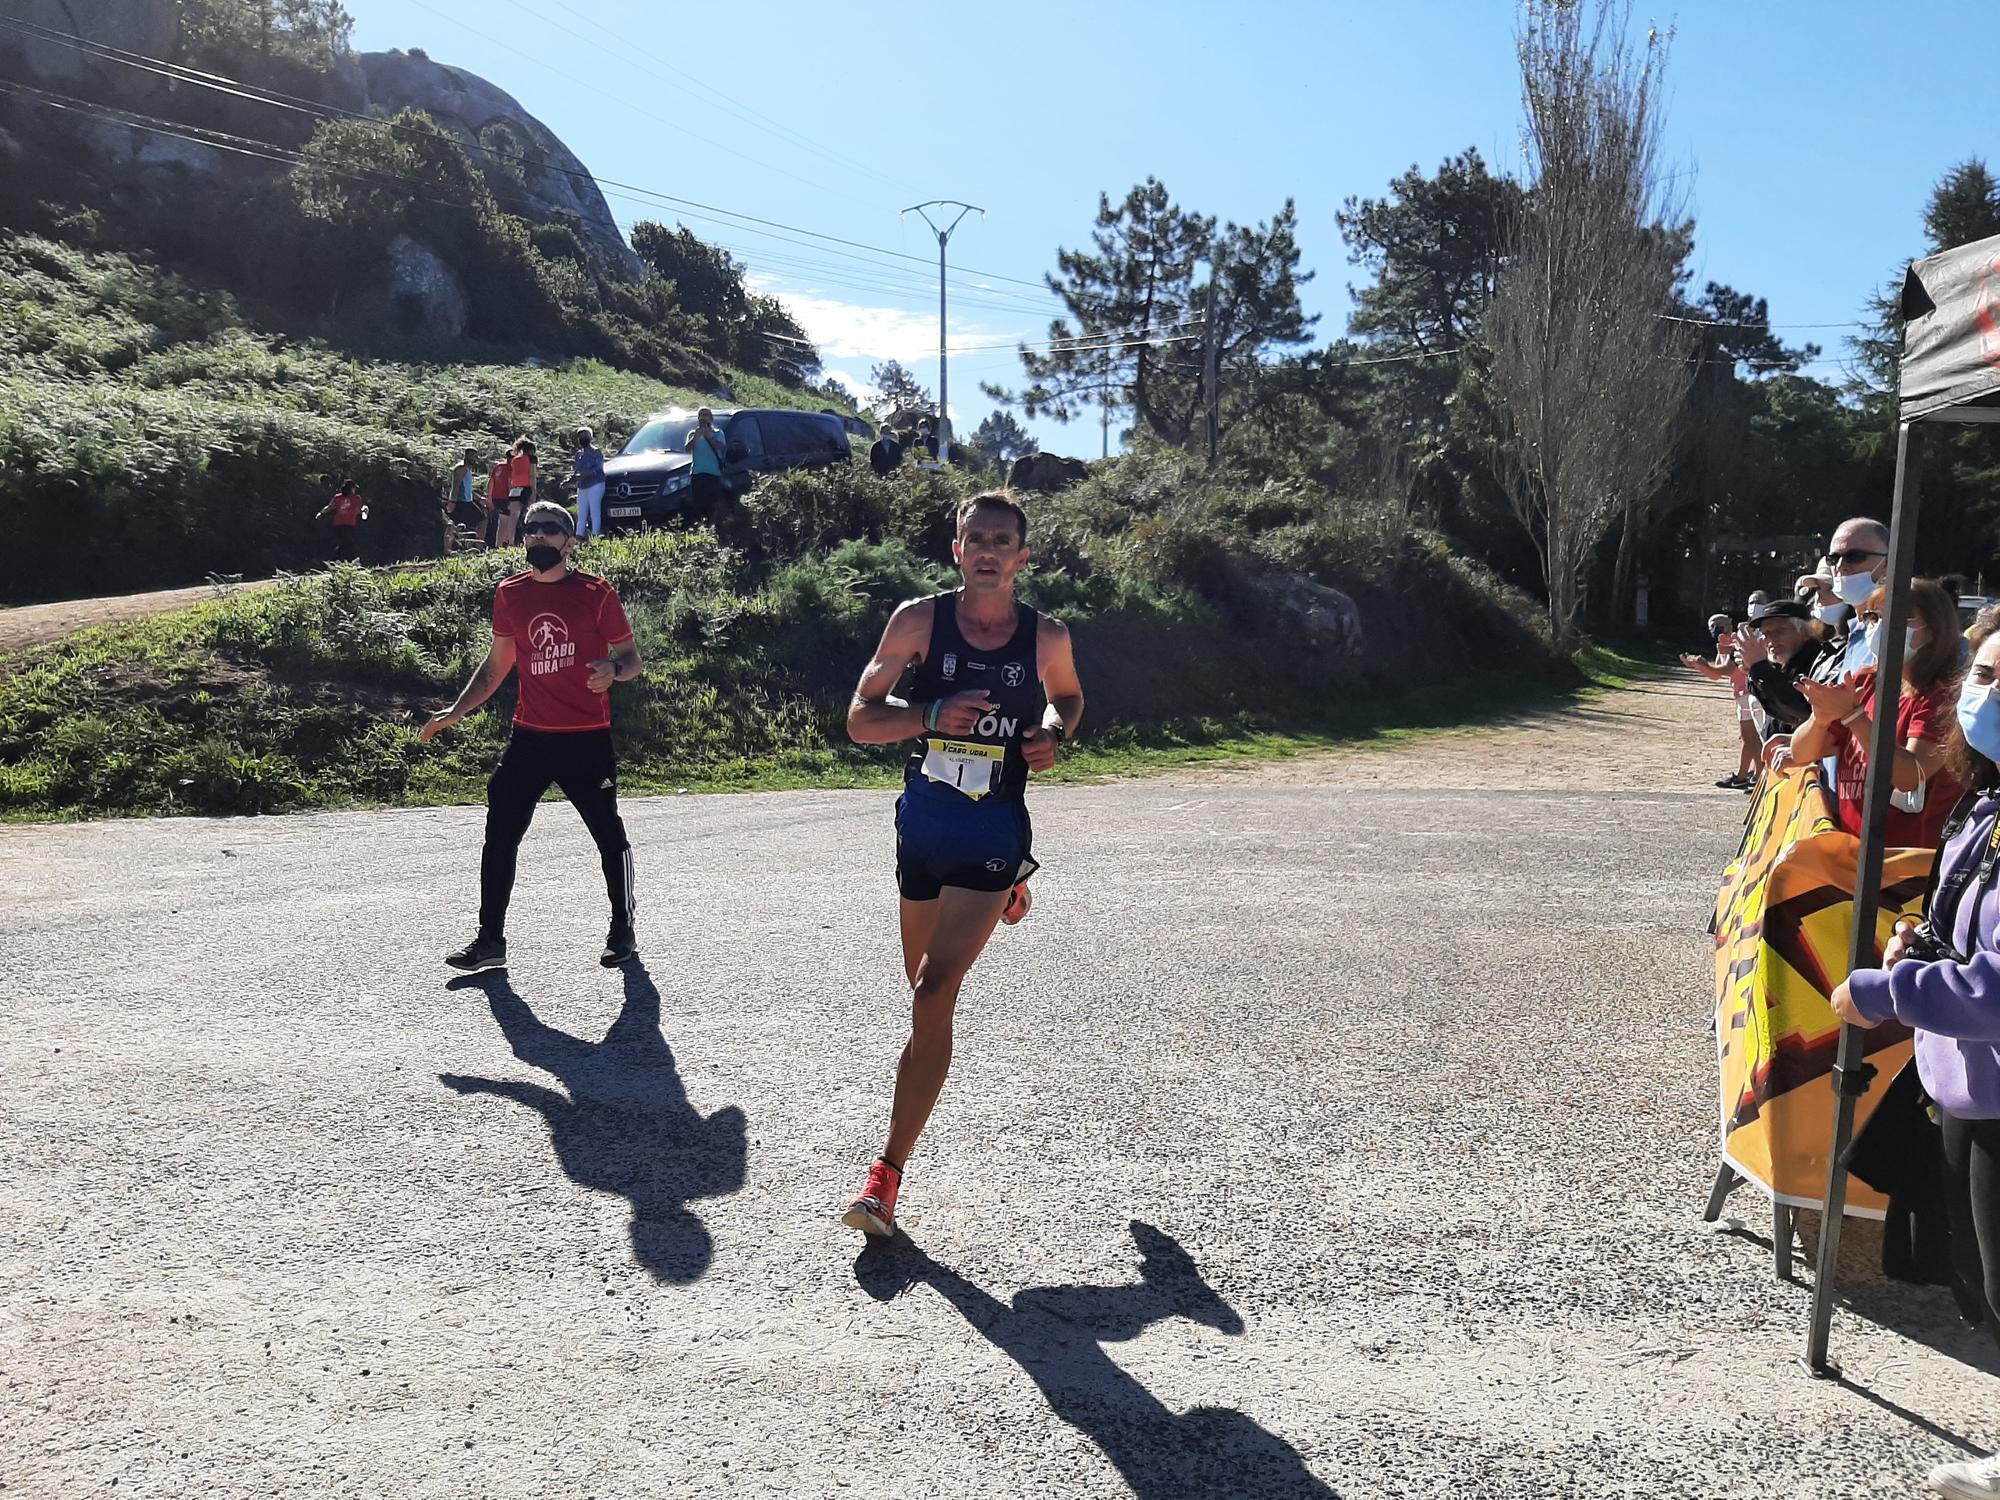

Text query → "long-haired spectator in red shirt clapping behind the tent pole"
[1792,578,1960,848]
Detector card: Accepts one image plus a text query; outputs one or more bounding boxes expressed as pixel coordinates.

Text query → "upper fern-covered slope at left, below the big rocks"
[0,234,844,602]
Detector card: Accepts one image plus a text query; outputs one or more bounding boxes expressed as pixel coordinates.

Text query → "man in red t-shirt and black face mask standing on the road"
[420,500,646,974]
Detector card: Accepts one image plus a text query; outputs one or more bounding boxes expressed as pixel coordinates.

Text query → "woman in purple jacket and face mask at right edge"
[1832,622,2000,1500]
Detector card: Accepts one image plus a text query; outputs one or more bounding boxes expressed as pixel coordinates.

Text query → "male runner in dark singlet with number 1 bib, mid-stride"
[840,492,1084,1236]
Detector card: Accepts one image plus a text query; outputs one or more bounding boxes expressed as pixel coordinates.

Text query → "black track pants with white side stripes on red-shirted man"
[480,724,632,938]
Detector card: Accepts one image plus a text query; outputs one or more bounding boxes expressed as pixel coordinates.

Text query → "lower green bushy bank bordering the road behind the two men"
[0,456,1582,818]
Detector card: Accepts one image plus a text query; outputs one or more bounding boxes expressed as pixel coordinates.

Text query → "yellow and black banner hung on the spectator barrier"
[1716,766,1936,1218]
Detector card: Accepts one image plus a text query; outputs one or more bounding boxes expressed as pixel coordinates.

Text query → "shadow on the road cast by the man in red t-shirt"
[438,962,748,1282]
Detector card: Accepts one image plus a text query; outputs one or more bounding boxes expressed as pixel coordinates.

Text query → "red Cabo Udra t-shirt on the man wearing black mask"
[494,570,632,734]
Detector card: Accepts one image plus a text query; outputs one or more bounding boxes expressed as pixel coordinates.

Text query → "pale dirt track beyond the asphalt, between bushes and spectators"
[1172,674,1736,798]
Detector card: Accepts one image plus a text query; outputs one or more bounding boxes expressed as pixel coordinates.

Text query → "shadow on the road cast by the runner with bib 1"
[854,1220,1338,1500]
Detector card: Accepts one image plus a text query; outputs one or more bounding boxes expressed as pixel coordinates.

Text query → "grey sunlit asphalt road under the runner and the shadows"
[0,724,2000,1500]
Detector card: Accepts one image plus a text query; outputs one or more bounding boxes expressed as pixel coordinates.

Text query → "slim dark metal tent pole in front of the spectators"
[1804,422,1922,1376]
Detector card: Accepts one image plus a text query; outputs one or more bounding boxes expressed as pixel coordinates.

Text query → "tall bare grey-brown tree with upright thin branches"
[1486,0,1692,644]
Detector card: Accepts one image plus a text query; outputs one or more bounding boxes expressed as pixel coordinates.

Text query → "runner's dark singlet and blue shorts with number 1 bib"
[896,594,1048,900]
